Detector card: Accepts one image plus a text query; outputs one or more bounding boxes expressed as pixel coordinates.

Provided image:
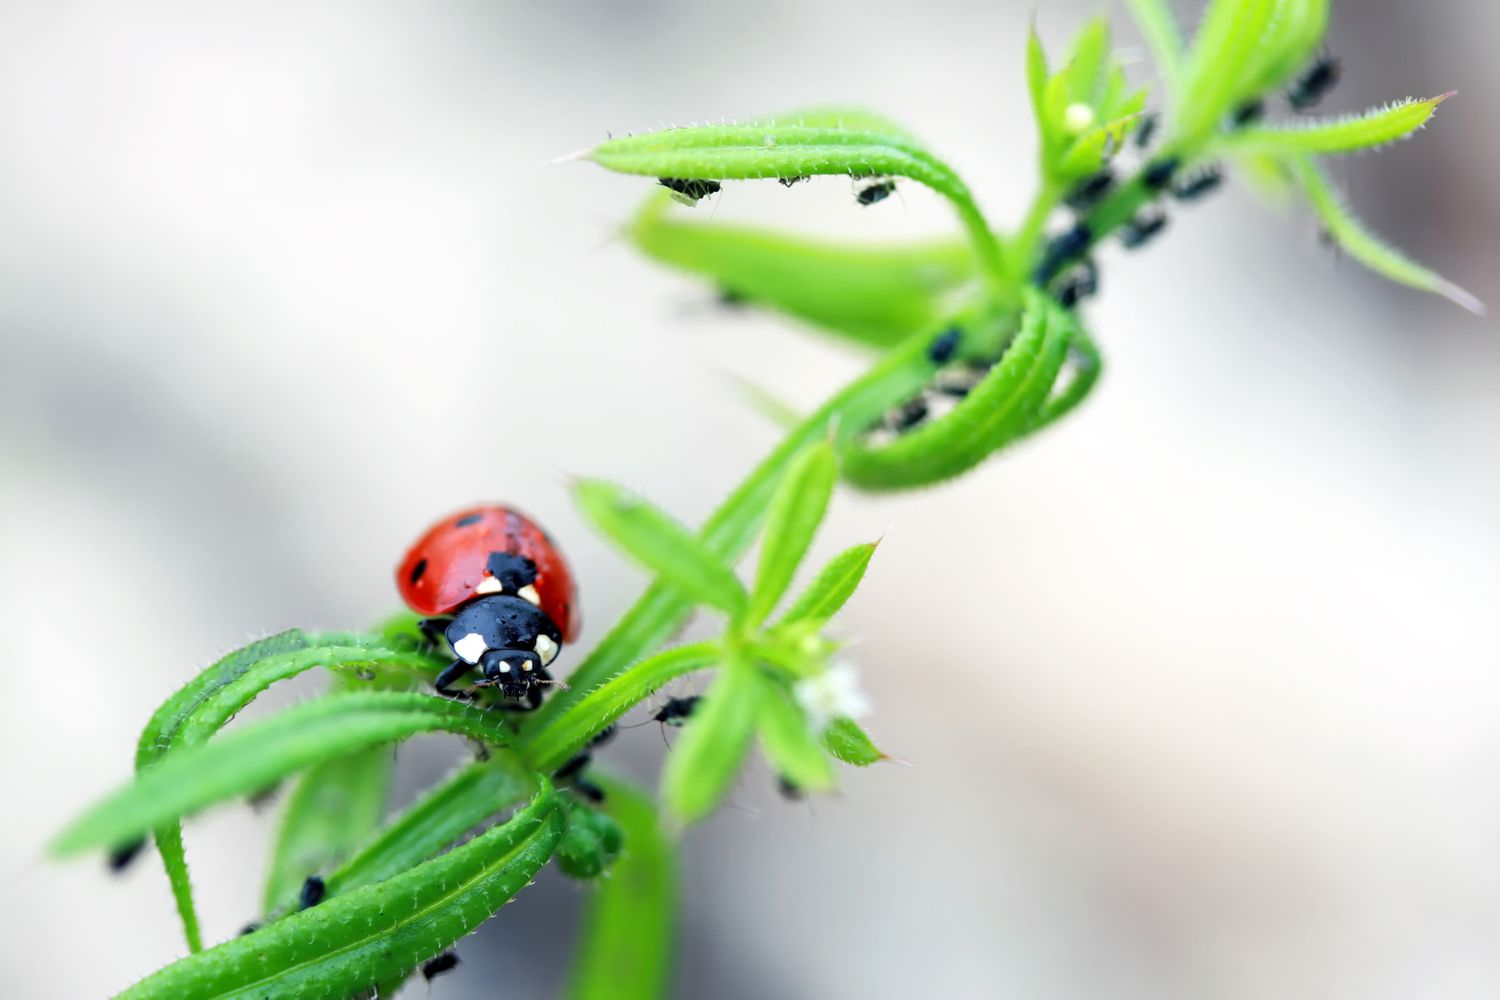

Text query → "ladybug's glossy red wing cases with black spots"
[396,504,582,642]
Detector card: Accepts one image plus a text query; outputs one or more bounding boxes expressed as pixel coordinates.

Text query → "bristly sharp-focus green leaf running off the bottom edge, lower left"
[108,789,563,1000]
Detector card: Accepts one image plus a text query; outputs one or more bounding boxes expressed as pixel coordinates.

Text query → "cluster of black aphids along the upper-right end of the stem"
[1032,55,1341,309]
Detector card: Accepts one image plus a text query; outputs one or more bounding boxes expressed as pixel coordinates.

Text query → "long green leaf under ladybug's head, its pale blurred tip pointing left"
[53,691,510,856]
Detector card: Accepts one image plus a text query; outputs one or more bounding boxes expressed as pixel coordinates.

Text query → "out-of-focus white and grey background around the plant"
[0,0,1500,1000]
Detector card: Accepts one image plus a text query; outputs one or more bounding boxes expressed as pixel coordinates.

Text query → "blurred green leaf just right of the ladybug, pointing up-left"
[573,480,749,618]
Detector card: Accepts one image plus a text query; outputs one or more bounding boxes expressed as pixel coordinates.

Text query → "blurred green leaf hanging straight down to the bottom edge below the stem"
[567,771,677,1000]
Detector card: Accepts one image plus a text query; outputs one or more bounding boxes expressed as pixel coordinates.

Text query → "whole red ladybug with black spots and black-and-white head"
[396,504,581,711]
